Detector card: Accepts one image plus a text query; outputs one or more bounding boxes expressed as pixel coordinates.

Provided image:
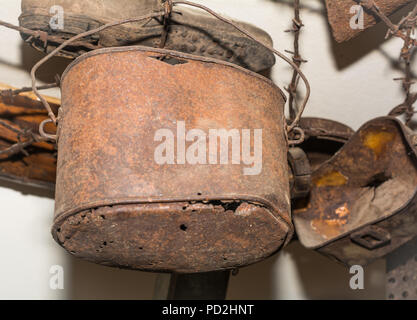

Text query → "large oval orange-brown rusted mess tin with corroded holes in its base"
[52,47,293,273]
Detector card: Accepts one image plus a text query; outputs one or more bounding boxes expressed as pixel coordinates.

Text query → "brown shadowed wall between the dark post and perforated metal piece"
[228,241,385,300]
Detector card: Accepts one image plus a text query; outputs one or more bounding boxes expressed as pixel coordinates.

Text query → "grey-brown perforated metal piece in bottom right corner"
[386,238,417,300]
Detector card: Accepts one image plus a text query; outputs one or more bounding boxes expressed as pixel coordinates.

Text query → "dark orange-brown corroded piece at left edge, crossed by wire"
[0,84,59,189]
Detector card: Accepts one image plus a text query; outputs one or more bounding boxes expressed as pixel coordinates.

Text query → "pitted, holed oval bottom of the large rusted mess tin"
[54,201,290,273]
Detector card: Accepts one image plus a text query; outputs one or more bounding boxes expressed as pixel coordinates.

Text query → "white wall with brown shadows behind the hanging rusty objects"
[0,0,412,299]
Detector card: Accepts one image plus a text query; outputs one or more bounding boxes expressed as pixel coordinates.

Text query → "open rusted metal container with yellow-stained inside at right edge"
[293,117,417,265]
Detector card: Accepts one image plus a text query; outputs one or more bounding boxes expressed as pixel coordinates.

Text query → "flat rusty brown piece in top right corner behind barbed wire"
[326,0,413,42]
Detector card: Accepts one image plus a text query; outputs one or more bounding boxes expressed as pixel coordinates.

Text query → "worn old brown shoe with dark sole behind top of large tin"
[19,0,275,72]
